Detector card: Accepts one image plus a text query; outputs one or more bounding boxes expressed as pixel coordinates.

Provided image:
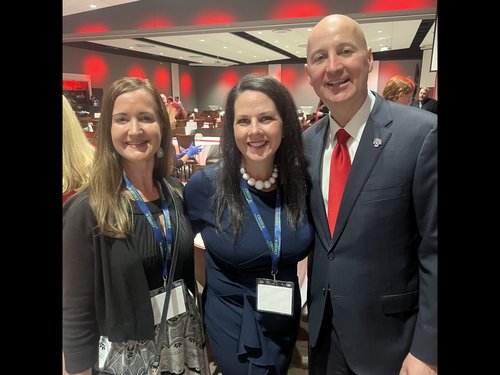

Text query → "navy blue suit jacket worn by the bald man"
[303,93,437,375]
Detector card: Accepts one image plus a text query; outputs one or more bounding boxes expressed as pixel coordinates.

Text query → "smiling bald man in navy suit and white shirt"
[303,15,437,375]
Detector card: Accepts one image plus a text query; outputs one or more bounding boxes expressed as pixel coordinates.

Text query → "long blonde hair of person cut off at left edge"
[62,95,94,203]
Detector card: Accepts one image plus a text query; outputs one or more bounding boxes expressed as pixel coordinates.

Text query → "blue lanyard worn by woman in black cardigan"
[123,172,173,280]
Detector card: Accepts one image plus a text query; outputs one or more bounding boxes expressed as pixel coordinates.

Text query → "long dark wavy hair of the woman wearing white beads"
[213,74,307,235]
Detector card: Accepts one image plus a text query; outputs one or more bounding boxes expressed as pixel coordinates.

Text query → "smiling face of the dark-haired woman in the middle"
[233,90,283,164]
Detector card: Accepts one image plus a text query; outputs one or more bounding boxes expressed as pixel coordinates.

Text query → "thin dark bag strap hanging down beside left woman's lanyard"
[150,179,179,375]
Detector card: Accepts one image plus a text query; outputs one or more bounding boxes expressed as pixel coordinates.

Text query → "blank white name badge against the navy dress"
[257,278,294,315]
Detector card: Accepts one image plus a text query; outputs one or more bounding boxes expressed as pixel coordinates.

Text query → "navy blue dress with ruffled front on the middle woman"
[184,165,314,375]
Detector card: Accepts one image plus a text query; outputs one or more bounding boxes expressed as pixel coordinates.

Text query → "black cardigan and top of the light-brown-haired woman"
[63,178,195,372]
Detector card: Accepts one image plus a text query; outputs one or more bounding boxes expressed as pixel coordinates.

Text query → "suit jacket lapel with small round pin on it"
[327,95,392,248]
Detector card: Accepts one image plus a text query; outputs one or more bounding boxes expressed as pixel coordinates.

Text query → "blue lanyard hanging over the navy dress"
[240,179,281,277]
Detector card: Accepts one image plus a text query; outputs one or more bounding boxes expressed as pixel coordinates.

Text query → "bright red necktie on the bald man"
[328,129,351,236]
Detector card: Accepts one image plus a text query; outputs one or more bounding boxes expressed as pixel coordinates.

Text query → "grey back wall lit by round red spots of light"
[63,46,422,111]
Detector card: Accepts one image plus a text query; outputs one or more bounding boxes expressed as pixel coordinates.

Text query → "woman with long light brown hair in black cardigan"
[63,78,205,375]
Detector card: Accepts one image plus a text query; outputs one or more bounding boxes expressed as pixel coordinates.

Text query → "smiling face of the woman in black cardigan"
[111,89,161,167]
